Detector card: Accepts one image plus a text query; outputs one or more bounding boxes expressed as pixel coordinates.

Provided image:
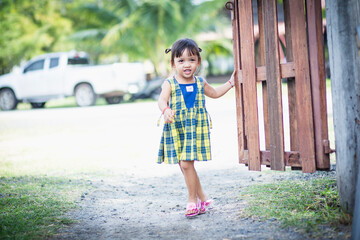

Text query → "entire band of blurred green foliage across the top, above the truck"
[0,0,230,74]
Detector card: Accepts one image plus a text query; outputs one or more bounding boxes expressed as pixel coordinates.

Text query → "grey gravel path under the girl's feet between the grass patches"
[55,167,346,240]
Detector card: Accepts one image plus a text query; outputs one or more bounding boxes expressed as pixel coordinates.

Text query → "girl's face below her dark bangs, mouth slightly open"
[172,49,201,81]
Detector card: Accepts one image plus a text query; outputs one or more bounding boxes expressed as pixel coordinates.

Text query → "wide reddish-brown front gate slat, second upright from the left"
[238,0,261,171]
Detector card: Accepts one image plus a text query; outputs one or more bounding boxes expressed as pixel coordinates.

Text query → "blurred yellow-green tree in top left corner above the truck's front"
[0,0,72,74]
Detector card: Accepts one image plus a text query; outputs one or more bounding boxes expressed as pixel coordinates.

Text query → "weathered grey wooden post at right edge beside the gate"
[326,0,360,213]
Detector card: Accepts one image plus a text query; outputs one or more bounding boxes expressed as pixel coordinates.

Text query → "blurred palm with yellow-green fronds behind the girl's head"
[95,0,231,74]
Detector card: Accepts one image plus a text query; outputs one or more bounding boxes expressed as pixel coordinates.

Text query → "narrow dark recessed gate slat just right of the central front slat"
[283,0,298,151]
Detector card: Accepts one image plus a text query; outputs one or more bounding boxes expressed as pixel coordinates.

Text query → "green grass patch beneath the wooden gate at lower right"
[241,177,351,237]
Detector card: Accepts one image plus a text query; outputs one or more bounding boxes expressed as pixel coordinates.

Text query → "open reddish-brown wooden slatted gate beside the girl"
[225,0,332,173]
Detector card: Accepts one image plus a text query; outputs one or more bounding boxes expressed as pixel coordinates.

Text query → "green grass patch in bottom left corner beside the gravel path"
[0,176,86,239]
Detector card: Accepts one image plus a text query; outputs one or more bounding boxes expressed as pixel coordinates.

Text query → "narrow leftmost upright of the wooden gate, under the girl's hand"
[229,1,246,163]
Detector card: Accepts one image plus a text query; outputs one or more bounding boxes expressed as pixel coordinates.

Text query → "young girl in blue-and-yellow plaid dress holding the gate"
[158,38,234,217]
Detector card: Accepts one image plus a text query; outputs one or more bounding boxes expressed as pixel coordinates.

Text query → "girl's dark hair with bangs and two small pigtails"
[165,38,202,64]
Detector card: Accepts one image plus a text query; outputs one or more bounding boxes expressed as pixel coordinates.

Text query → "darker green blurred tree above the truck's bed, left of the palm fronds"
[65,0,137,63]
